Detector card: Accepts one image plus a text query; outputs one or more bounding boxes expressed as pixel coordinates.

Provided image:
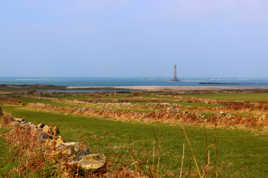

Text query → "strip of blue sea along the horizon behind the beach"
[0,77,268,86]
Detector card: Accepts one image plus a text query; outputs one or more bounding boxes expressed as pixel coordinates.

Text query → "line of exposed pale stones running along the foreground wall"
[0,112,106,176]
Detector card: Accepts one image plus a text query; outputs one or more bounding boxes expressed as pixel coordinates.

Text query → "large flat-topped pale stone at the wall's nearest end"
[78,154,106,171]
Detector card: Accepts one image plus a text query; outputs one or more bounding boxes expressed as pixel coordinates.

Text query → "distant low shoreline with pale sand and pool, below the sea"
[3,84,268,94]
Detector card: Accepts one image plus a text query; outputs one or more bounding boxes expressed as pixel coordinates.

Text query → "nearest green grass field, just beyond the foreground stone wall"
[4,107,268,177]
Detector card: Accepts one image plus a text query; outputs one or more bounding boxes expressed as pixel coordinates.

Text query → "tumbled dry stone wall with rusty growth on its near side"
[0,110,106,177]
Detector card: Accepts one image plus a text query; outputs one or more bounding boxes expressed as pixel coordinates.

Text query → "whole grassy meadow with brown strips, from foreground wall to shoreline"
[0,88,268,178]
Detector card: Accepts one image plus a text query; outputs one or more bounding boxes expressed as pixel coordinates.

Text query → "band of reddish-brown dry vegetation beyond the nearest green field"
[24,98,268,129]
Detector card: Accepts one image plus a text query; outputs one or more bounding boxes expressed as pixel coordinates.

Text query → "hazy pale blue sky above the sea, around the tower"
[0,0,268,78]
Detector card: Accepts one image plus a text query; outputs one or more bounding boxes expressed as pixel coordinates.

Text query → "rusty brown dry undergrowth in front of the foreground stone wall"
[0,114,147,178]
